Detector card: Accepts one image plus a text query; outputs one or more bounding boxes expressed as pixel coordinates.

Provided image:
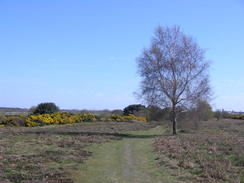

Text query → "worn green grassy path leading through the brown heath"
[73,127,177,183]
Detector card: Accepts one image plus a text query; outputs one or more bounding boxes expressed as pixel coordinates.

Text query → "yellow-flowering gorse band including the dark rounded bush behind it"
[0,103,147,127]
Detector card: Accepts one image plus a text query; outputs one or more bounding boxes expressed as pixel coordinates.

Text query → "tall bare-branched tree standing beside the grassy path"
[138,26,210,135]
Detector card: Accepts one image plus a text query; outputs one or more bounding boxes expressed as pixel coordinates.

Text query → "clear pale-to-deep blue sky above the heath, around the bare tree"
[0,0,244,111]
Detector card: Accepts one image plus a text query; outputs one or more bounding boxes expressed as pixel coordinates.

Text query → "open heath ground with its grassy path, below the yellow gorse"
[0,120,244,183]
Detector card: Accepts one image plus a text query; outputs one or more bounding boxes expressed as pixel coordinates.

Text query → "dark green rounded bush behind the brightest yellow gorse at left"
[33,102,59,114]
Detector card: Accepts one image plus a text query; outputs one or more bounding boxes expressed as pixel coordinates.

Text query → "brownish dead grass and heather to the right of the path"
[154,120,244,183]
